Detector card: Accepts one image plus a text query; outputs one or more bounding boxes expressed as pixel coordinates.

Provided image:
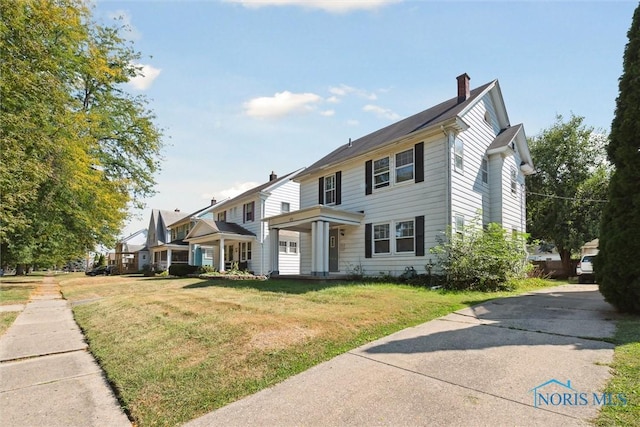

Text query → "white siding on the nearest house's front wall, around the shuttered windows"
[300,135,447,275]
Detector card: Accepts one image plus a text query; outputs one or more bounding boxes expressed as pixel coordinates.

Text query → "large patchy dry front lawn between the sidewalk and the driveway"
[59,276,557,426]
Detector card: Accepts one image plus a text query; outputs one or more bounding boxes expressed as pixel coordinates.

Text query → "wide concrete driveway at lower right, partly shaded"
[187,285,616,427]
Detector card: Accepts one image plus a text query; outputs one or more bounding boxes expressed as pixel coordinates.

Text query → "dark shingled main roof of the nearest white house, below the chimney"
[299,80,498,176]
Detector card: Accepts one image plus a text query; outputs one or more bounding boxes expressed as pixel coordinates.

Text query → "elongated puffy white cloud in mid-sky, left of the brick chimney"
[244,91,322,118]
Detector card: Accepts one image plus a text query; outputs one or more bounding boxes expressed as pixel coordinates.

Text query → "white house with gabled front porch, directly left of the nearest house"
[184,169,303,274]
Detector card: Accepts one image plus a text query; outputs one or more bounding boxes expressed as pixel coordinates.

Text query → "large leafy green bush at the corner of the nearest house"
[425,223,527,291]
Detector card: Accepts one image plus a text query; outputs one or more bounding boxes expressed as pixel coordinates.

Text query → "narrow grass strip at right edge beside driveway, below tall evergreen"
[595,316,640,426]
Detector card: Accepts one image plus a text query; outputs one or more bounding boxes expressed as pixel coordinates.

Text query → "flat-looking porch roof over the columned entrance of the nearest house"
[263,205,364,232]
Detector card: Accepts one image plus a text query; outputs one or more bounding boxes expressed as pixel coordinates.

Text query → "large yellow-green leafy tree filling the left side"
[0,0,162,265]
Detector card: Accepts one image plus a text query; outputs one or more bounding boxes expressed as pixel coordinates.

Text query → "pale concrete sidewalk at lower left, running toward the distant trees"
[0,277,131,426]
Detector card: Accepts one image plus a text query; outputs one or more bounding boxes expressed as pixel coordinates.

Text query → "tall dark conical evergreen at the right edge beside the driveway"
[595,6,640,313]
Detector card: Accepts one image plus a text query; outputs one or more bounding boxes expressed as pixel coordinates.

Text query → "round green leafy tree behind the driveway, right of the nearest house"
[527,114,610,271]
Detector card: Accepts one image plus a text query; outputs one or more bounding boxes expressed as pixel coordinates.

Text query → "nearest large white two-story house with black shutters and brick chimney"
[268,74,534,276]
